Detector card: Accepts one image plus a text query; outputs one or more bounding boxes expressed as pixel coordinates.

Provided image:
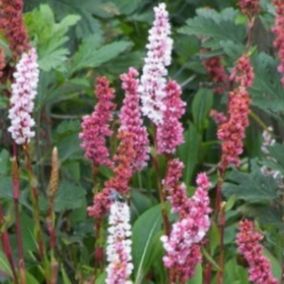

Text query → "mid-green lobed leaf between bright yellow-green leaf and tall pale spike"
[70,36,131,73]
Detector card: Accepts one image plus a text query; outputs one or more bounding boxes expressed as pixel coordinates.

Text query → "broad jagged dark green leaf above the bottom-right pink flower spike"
[223,162,277,203]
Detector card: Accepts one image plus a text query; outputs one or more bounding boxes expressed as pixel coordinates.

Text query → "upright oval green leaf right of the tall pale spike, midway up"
[192,89,213,131]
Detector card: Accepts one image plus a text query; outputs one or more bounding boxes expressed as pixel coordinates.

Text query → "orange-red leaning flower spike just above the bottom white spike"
[88,132,136,218]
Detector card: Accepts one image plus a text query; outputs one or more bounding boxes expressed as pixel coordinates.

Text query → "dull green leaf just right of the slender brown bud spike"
[55,181,86,212]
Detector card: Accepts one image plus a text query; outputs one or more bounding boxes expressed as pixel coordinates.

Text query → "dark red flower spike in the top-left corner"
[0,0,30,56]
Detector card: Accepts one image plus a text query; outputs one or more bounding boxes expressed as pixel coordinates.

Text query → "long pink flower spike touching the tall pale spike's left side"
[119,68,150,171]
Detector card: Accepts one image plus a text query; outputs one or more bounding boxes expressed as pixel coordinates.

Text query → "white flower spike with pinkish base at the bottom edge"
[106,201,133,284]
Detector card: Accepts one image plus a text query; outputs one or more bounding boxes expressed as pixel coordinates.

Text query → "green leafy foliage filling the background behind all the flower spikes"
[0,0,284,284]
